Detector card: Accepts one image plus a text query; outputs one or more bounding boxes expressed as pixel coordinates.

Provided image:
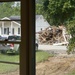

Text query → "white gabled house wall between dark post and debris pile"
[35,15,50,32]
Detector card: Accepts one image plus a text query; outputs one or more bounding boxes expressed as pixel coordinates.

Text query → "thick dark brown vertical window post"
[0,0,35,75]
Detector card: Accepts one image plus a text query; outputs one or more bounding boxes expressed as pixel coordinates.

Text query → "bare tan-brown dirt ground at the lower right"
[36,54,75,75]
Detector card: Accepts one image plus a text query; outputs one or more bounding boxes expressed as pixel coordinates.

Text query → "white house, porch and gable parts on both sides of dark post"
[0,15,50,36]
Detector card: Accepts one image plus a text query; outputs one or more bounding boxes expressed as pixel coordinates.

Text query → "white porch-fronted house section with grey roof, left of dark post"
[0,16,21,36]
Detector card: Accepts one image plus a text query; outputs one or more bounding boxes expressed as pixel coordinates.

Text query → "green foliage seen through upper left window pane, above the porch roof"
[0,2,20,18]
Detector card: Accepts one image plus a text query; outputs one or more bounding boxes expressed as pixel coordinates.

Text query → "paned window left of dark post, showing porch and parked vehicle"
[0,0,21,75]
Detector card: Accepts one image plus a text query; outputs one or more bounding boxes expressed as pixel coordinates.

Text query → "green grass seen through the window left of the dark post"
[0,54,19,73]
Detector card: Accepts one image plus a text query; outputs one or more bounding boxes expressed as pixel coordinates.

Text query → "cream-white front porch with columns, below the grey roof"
[0,21,21,36]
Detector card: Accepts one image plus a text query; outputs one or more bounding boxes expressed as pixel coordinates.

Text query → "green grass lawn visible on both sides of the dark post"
[0,50,53,74]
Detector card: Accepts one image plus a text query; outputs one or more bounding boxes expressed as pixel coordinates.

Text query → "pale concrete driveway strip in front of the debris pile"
[38,45,67,53]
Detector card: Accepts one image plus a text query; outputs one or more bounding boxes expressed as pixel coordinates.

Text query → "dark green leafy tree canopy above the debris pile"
[48,0,75,25]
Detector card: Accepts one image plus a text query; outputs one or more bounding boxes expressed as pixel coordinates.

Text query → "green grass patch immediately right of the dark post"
[36,50,54,63]
